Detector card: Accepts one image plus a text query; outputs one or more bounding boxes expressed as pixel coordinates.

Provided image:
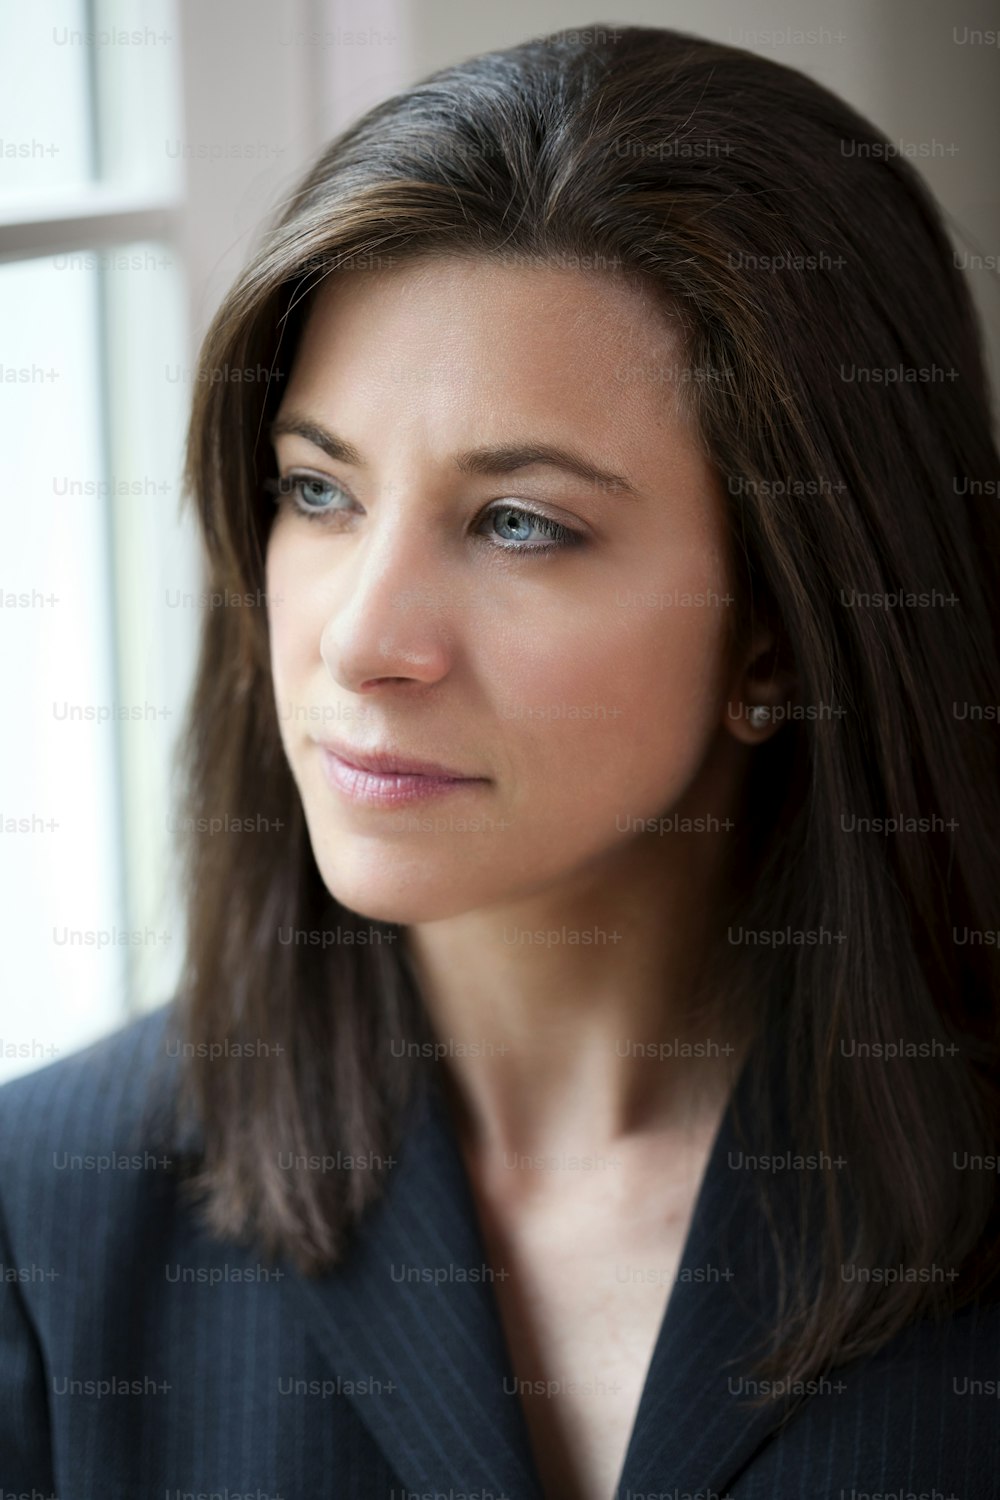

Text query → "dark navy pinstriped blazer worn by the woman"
[0,1007,1000,1500]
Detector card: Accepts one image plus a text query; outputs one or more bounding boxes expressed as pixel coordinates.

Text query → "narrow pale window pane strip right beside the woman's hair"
[105,243,204,1010]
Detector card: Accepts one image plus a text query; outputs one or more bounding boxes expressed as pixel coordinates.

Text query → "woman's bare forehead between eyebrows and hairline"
[286,255,701,438]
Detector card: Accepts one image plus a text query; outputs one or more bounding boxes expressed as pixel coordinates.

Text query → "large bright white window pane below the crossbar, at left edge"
[0,260,127,1077]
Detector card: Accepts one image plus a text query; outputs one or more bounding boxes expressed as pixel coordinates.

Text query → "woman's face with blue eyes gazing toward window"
[267,258,749,923]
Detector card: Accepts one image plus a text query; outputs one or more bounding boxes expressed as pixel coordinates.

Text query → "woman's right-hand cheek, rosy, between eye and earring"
[496,551,729,827]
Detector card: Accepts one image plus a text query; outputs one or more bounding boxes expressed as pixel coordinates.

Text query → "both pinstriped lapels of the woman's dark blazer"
[282,1032,801,1500]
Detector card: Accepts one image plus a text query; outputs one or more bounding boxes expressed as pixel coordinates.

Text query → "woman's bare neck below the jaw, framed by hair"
[405,831,744,1160]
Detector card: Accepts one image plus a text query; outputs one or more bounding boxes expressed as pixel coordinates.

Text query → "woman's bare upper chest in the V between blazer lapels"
[467,1140,710,1500]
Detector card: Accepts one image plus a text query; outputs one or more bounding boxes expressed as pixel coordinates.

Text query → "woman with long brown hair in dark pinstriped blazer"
[1,27,1000,1500]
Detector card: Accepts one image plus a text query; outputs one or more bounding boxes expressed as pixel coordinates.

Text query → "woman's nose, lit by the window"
[319,507,457,693]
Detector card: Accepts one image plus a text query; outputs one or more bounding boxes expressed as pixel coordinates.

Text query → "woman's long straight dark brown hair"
[164,27,1000,1380]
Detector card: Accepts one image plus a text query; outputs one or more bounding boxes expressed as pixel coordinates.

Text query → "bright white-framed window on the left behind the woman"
[0,0,198,1079]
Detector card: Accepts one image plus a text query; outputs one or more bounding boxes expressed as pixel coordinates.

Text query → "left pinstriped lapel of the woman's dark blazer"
[282,1085,543,1500]
